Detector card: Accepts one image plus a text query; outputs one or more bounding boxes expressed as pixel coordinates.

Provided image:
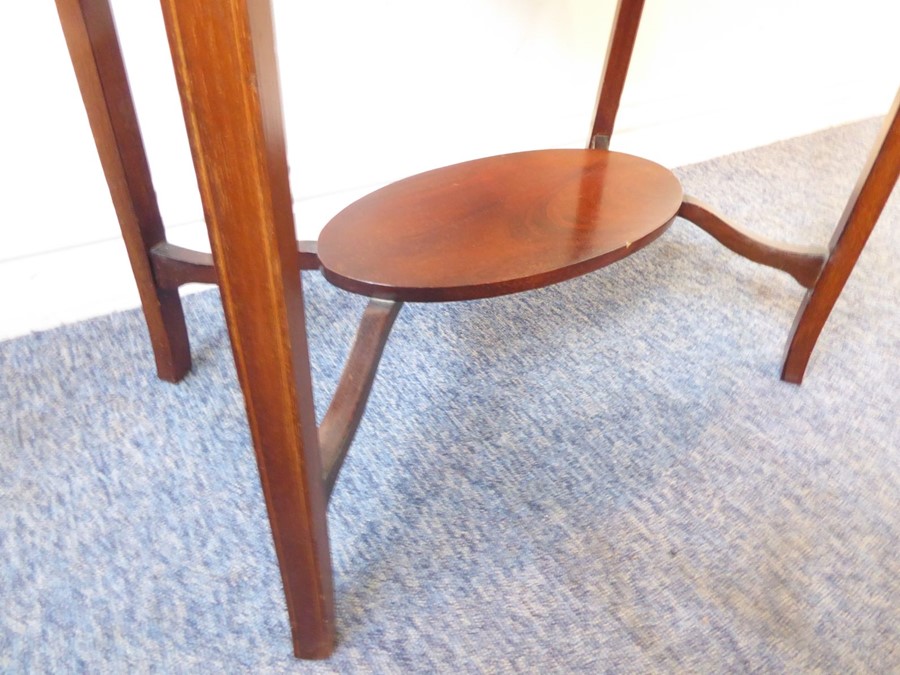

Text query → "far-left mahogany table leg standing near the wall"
[56,0,191,382]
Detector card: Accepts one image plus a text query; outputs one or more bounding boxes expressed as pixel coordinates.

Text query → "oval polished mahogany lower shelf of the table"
[319,150,682,302]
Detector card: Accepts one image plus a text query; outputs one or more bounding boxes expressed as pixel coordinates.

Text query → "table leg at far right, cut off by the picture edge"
[781,91,900,384]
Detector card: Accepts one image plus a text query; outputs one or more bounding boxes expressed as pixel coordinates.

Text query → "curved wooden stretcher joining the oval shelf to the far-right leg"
[678,197,828,288]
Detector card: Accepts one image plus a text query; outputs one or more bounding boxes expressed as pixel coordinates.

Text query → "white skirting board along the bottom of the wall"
[0,82,894,339]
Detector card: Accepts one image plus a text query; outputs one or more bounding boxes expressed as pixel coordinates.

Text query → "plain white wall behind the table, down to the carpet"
[0,0,900,337]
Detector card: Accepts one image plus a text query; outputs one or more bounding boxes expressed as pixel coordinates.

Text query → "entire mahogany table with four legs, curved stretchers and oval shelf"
[57,0,900,658]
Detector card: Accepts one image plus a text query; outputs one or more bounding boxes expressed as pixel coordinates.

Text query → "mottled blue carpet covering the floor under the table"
[0,122,900,673]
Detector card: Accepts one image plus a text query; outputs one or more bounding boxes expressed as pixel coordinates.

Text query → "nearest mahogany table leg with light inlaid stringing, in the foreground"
[162,0,335,658]
